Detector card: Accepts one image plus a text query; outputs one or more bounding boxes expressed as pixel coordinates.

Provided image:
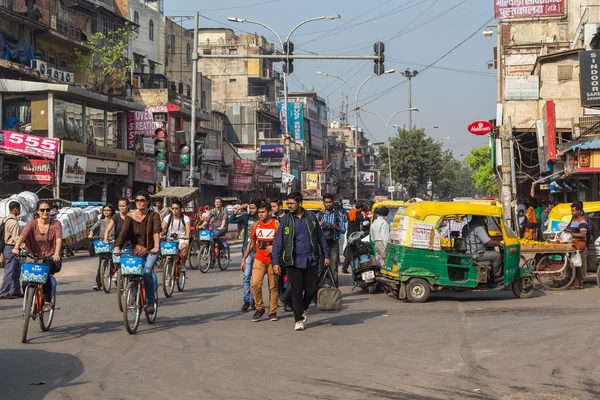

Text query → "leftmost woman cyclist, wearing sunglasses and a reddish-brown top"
[12,200,62,312]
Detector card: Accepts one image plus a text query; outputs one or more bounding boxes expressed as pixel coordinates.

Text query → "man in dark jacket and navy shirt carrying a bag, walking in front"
[271,192,329,331]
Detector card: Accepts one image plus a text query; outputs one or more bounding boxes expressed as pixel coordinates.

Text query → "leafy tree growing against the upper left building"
[74,23,135,93]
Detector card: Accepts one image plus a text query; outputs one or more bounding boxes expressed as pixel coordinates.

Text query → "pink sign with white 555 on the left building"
[0,131,60,160]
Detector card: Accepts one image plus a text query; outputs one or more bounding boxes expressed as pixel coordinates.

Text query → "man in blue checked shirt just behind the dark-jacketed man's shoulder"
[317,193,346,287]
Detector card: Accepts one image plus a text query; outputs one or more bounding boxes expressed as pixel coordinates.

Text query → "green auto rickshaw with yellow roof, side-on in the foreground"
[378,202,534,303]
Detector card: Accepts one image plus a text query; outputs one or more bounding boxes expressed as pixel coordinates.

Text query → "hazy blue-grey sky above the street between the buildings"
[164,0,496,159]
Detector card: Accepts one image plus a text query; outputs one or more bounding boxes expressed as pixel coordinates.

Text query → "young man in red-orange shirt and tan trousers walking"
[242,202,279,322]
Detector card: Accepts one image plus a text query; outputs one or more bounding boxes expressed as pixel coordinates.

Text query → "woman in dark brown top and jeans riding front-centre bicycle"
[114,191,162,315]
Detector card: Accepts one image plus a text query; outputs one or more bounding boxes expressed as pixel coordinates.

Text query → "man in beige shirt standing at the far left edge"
[0,201,23,299]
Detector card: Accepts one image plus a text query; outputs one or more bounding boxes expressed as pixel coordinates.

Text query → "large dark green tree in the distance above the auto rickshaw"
[378,129,475,200]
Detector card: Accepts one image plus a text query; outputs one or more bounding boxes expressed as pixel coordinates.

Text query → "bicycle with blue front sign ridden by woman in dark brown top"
[121,255,158,335]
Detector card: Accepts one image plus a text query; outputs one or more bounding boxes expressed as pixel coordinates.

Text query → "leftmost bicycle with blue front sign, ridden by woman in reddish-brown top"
[15,252,57,343]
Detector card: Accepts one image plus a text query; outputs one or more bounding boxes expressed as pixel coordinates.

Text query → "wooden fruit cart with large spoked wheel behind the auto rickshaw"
[521,243,575,290]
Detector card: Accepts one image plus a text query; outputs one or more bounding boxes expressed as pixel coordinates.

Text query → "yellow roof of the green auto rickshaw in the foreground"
[404,201,502,220]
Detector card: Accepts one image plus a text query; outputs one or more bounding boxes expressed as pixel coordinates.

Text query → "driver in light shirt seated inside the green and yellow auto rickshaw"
[462,215,504,285]
